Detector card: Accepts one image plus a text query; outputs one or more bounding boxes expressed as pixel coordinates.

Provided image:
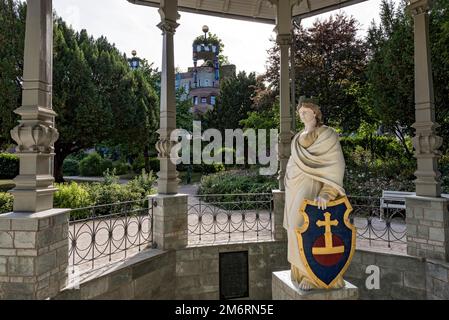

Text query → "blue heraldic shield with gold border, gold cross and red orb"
[296,196,356,289]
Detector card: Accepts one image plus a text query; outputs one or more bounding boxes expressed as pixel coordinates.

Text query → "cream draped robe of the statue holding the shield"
[284,126,345,277]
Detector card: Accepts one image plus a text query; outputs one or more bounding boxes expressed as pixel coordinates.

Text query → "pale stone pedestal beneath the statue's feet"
[272,270,359,300]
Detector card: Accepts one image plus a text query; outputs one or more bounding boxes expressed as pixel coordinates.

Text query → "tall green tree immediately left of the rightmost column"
[365,0,415,158]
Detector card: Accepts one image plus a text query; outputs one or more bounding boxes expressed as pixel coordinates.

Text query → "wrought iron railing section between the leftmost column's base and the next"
[68,199,153,268]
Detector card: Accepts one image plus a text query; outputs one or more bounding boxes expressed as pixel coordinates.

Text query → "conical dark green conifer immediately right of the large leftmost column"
[53,18,113,181]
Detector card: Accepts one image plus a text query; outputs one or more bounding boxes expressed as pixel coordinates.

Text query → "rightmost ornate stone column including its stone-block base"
[406,0,449,261]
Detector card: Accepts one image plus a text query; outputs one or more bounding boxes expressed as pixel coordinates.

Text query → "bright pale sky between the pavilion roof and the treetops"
[53,0,399,74]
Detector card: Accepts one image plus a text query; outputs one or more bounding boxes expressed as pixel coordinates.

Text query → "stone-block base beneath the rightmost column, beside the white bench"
[405,196,449,261]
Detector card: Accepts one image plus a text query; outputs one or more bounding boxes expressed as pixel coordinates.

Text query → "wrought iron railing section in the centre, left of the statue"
[188,193,273,244]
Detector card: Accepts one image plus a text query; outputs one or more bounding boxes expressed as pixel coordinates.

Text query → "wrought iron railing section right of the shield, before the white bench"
[348,197,407,248]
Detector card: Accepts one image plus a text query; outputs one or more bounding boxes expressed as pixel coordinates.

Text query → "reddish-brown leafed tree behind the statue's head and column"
[266,14,366,132]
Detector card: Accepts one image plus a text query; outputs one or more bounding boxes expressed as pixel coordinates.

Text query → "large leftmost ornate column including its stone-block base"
[0,0,68,299]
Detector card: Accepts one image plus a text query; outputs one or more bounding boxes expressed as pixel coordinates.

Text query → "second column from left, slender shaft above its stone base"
[156,0,179,194]
